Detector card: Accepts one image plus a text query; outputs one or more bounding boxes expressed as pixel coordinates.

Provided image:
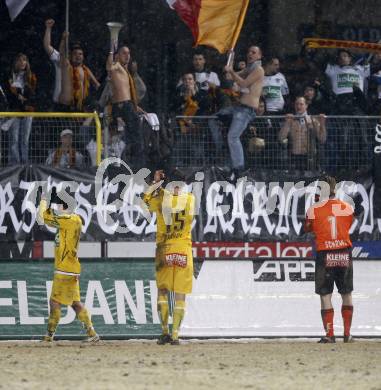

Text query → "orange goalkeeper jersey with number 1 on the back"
[307,199,353,251]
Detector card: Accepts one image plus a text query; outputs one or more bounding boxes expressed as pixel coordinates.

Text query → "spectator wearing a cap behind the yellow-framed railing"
[46,129,83,169]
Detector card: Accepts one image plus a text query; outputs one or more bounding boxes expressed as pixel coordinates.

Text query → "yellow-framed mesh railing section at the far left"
[0,112,102,166]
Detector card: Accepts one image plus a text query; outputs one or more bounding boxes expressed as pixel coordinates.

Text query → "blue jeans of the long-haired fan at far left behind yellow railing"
[8,117,32,165]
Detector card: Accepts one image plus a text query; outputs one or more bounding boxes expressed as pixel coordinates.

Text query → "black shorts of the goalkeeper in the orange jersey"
[315,248,353,295]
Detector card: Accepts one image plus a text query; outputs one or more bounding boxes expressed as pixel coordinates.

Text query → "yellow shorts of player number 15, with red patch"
[155,244,193,294]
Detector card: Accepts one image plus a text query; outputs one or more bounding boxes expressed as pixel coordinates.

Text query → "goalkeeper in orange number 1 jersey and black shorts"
[304,176,354,344]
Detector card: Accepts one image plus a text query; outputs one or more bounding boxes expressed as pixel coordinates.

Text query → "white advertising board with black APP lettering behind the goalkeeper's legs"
[183,260,381,337]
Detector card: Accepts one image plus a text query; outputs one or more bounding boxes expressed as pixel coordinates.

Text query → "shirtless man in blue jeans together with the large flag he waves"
[167,0,264,181]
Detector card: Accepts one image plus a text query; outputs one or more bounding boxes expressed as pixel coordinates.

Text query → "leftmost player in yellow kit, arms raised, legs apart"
[38,188,99,342]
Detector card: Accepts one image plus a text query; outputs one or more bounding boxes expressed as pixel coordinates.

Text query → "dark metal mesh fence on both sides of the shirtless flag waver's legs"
[172,116,380,170]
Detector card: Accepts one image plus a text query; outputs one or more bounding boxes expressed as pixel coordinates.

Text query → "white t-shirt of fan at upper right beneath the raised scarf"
[325,64,370,95]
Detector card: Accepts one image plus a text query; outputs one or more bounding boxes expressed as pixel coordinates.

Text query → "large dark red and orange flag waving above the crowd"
[167,0,249,53]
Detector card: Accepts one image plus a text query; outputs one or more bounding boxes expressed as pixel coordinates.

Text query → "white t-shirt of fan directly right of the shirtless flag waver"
[262,73,289,112]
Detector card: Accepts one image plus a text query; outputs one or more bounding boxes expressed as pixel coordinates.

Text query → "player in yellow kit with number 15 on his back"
[143,171,195,345]
